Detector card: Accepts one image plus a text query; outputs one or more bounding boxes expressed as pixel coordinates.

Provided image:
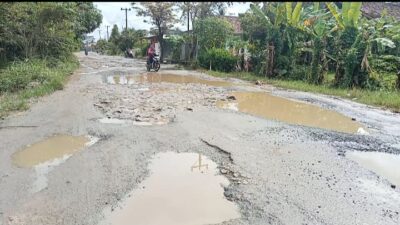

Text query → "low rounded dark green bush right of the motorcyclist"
[198,48,237,72]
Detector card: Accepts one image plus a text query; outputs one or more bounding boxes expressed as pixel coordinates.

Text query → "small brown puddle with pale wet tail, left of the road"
[12,135,99,193]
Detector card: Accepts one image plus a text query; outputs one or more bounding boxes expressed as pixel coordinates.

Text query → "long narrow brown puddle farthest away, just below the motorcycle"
[106,73,232,87]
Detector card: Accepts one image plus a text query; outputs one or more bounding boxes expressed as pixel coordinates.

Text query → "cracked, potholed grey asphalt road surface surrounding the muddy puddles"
[0,53,400,225]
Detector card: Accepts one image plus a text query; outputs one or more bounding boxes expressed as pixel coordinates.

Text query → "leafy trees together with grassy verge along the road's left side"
[0,2,102,118]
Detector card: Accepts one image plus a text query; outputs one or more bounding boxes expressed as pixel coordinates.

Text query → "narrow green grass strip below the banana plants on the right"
[202,70,400,112]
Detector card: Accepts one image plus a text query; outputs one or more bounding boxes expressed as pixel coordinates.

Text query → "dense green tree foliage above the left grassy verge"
[0,2,101,60]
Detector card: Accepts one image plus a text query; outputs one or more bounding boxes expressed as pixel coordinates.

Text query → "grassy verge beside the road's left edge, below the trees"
[0,57,79,118]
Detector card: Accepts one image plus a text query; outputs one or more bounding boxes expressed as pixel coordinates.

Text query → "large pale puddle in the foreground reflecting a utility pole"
[101,152,240,225]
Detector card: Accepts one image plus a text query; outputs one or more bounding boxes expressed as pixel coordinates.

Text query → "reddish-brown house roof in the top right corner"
[361,2,400,20]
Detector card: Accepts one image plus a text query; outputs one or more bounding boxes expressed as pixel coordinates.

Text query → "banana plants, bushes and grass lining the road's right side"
[176,2,400,111]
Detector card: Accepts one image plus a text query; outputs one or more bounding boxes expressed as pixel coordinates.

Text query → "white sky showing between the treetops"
[89,2,250,41]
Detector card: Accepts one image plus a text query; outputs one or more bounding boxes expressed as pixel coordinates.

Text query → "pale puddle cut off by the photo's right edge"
[346,151,400,187]
